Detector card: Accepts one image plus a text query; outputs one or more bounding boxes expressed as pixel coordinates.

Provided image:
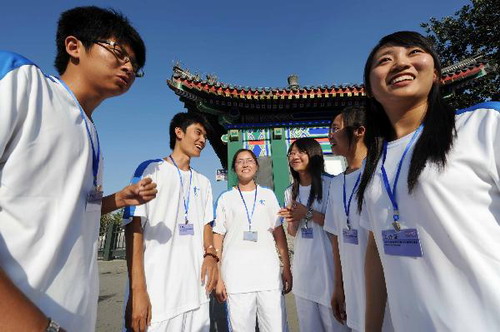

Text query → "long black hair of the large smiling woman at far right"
[357,31,456,211]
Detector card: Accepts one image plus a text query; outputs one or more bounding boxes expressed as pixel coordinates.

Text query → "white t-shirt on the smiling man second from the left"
[124,159,213,322]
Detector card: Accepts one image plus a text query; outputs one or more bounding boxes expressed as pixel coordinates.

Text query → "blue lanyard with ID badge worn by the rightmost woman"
[381,124,424,257]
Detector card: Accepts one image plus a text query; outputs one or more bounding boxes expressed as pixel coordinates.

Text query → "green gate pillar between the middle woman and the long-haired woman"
[271,128,290,206]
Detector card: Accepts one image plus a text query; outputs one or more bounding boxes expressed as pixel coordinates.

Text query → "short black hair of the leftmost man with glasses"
[54,6,146,75]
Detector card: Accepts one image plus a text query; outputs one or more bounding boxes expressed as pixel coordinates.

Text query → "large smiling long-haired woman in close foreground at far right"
[358,31,500,332]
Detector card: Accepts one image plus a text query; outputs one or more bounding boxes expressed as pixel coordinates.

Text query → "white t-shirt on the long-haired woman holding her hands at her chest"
[285,175,334,308]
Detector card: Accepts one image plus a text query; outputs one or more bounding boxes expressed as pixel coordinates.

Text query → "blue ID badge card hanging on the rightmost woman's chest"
[382,228,422,257]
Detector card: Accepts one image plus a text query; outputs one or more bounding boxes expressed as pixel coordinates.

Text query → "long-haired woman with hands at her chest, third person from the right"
[280,137,343,331]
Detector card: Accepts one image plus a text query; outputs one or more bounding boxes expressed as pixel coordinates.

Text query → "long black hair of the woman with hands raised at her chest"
[288,137,325,207]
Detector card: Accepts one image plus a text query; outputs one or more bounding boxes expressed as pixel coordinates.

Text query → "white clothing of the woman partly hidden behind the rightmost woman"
[323,169,368,331]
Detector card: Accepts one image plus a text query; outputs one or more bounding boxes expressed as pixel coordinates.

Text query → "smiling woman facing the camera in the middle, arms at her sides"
[213,149,292,332]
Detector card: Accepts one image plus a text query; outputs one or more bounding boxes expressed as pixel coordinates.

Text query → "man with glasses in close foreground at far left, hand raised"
[0,7,156,331]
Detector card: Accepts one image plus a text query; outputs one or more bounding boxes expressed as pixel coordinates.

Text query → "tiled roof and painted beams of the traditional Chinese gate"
[167,55,495,176]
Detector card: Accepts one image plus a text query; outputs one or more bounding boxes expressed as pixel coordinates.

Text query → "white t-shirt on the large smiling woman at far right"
[361,102,500,331]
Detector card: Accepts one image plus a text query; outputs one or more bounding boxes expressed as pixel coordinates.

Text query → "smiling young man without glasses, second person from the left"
[124,113,218,332]
